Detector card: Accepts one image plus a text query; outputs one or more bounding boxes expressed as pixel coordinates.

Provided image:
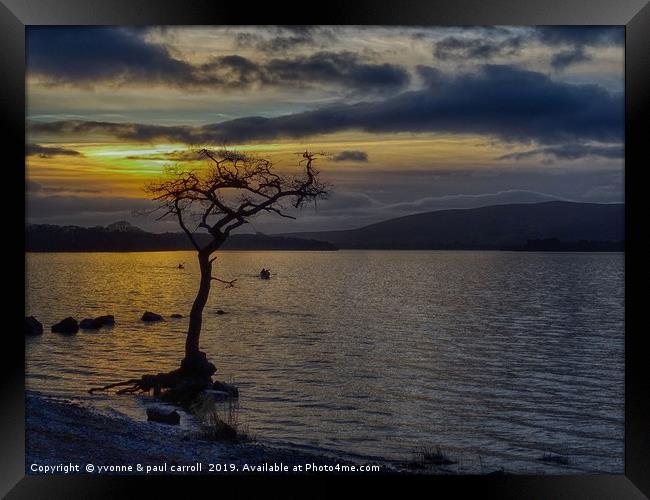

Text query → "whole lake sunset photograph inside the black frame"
[25,25,625,475]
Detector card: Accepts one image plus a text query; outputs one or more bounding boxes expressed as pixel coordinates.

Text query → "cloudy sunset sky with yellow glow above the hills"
[26,26,624,233]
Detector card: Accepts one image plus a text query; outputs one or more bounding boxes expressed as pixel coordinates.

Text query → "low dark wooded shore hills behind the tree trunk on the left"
[25,221,336,252]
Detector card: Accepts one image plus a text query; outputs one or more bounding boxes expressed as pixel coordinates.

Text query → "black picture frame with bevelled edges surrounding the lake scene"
[0,0,650,499]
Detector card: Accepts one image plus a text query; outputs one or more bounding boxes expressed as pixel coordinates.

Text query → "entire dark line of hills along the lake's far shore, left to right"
[26,201,625,252]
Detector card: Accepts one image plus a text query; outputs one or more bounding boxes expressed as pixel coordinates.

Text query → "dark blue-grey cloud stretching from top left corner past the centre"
[27,27,409,92]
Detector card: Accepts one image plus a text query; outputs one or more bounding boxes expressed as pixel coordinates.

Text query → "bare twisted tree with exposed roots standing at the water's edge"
[90,149,327,399]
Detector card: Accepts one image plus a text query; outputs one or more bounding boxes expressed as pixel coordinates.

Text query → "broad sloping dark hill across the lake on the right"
[285,201,625,251]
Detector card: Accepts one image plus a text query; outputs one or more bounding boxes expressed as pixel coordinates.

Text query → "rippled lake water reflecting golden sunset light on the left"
[26,251,624,474]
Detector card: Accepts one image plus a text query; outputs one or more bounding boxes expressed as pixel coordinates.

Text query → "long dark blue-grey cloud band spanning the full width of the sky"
[30,65,623,144]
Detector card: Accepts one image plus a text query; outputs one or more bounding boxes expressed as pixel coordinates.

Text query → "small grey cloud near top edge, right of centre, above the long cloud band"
[433,36,523,61]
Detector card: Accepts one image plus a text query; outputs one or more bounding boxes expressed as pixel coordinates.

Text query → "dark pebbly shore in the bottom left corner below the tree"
[25,393,388,475]
